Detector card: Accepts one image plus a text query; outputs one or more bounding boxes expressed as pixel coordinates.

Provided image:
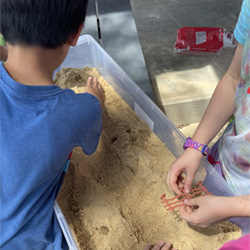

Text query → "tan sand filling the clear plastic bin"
[56,68,241,250]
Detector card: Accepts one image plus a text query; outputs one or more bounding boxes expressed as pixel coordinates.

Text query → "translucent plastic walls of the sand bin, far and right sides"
[55,35,250,249]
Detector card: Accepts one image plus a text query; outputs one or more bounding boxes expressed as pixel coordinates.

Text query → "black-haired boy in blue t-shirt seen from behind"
[0,0,103,250]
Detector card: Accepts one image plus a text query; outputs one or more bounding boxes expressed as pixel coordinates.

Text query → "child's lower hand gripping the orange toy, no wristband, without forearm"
[179,195,230,228]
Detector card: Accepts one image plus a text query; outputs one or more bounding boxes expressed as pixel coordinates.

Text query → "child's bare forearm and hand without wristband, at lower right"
[180,195,250,227]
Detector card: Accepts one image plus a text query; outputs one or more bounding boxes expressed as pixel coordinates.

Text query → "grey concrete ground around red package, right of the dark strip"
[130,0,242,136]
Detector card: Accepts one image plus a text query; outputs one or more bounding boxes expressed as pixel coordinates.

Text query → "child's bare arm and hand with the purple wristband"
[167,43,244,194]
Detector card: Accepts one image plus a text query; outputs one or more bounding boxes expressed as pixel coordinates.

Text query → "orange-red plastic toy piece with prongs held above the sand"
[160,181,212,211]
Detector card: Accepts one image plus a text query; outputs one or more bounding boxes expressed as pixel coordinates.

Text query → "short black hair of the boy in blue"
[0,0,88,48]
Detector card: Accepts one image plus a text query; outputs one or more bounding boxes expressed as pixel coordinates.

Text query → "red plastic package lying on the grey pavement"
[174,27,235,53]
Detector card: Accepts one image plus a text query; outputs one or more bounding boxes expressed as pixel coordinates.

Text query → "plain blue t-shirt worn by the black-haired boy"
[0,63,102,250]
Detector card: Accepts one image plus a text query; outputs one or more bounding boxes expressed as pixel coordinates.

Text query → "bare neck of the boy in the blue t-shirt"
[4,45,69,86]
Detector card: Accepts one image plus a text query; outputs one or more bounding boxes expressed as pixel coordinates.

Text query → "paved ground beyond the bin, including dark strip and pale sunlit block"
[82,0,242,136]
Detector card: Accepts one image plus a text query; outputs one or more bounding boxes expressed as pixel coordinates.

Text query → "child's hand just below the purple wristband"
[167,148,202,194]
